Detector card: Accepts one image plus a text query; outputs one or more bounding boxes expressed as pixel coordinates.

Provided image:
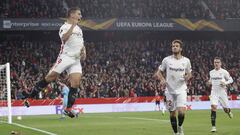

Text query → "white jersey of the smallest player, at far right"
[209,68,233,90]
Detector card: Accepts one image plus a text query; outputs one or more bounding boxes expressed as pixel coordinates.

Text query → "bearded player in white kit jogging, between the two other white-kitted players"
[154,40,192,135]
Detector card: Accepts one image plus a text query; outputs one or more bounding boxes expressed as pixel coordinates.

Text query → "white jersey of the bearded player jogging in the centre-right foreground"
[159,55,192,94]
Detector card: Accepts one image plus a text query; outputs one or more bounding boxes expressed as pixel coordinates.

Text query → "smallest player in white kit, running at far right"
[208,57,233,132]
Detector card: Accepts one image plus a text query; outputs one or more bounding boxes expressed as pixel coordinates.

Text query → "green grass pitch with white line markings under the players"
[0,109,240,135]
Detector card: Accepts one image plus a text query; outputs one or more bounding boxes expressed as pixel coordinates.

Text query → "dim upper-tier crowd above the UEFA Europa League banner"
[0,0,240,19]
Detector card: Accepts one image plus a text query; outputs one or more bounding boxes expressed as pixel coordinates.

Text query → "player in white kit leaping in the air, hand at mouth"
[23,7,86,117]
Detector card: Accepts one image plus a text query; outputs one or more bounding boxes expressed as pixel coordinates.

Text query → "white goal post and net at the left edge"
[0,63,12,123]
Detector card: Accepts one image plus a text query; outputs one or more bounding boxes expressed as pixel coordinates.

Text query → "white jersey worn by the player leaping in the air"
[59,22,84,58]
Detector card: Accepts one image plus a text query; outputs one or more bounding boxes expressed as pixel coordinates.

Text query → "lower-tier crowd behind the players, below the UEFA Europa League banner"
[0,40,240,99]
